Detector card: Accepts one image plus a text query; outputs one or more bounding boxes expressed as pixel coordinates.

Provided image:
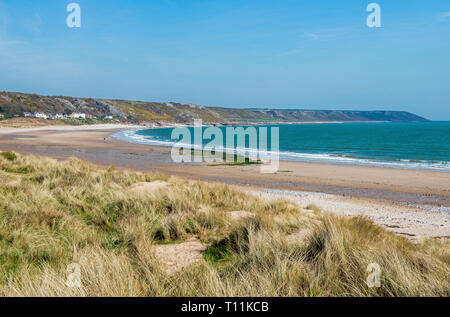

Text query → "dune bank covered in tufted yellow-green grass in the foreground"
[0,153,450,296]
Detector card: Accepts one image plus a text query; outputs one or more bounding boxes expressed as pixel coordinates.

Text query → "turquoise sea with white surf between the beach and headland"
[114,122,450,171]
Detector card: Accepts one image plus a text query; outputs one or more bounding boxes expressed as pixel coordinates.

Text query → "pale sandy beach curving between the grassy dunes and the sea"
[0,125,450,239]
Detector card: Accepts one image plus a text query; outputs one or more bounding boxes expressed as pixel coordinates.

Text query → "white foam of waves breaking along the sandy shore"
[111,129,450,172]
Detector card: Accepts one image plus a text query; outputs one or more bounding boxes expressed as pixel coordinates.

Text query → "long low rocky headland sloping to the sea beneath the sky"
[0,92,428,122]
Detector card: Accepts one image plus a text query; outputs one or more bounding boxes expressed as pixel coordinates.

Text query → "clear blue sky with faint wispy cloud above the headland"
[0,0,450,120]
